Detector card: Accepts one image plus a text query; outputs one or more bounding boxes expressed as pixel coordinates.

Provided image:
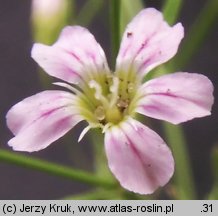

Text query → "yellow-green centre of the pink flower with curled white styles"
[77,69,138,130]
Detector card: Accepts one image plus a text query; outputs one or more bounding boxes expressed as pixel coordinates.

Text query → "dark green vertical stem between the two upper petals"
[110,0,120,67]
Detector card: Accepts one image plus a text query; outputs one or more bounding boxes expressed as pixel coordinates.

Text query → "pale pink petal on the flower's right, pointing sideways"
[136,72,214,124]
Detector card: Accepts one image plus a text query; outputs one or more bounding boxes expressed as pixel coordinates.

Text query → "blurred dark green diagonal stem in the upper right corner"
[170,0,218,69]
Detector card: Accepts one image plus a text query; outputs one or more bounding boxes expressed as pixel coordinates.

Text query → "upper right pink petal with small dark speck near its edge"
[116,8,184,76]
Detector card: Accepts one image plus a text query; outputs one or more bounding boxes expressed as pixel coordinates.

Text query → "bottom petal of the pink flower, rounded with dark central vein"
[105,119,174,194]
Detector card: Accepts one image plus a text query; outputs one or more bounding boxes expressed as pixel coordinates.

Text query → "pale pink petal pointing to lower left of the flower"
[6,91,82,152]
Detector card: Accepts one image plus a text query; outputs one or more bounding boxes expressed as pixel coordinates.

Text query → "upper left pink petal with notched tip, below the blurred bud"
[32,26,109,84]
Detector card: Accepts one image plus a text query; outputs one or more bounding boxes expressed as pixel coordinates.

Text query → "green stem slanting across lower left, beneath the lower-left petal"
[0,150,116,188]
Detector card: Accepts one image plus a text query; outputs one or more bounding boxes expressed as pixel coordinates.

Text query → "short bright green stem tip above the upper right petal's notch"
[162,0,183,24]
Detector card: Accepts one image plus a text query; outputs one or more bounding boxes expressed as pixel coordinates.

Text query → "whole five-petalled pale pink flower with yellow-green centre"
[7,8,213,194]
